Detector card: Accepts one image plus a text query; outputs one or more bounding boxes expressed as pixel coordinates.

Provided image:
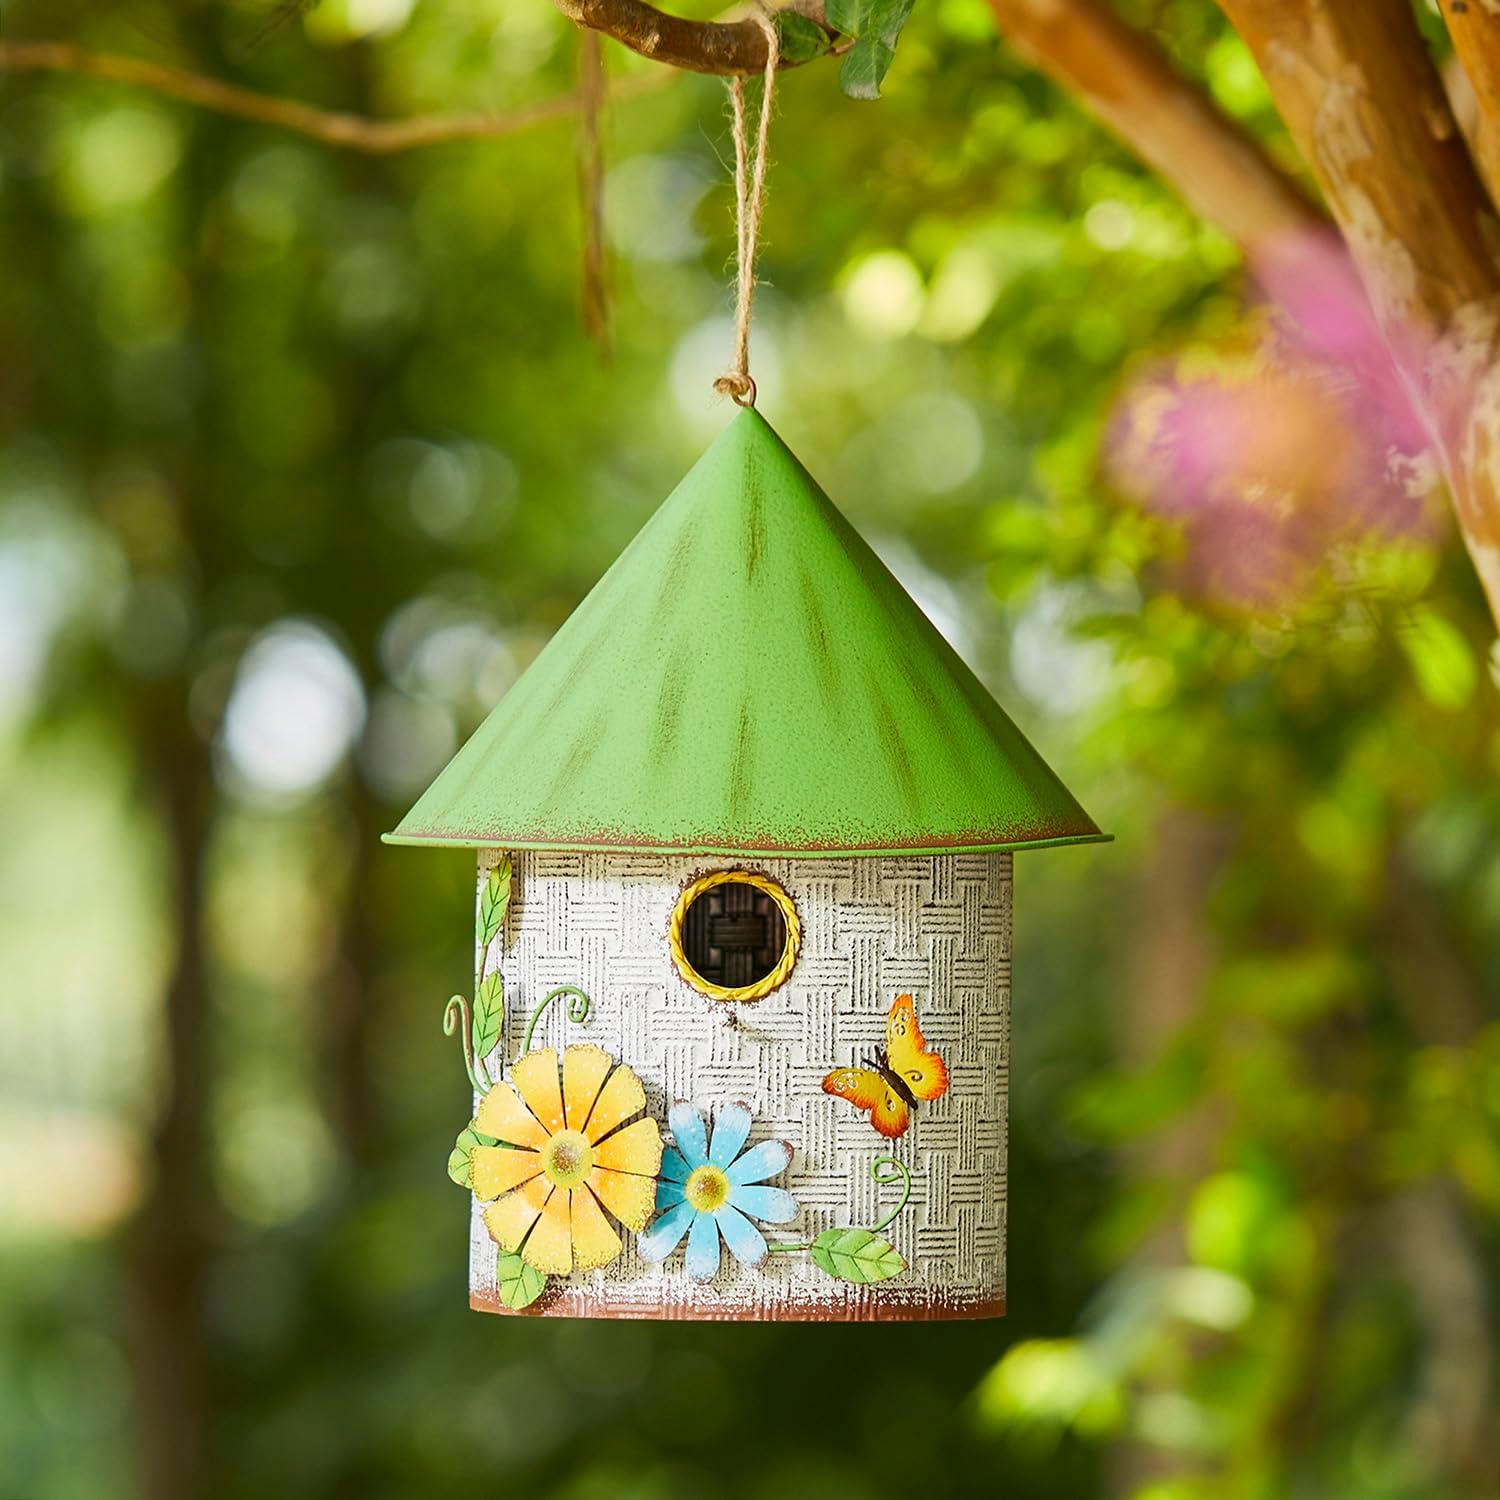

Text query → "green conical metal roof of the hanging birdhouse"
[389,410,1104,857]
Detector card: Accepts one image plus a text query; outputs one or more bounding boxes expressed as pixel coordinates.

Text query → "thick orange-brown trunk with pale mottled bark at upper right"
[1220,0,1500,633]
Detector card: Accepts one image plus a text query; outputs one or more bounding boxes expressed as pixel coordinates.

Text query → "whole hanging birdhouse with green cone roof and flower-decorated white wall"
[389,410,1106,1320]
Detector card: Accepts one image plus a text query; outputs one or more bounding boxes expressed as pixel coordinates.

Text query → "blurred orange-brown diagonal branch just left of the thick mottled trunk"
[990,0,1328,249]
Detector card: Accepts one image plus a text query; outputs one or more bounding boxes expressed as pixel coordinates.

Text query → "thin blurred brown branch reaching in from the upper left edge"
[0,42,672,156]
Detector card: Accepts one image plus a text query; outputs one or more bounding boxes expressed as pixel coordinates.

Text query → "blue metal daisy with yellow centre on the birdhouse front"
[639,1100,797,1281]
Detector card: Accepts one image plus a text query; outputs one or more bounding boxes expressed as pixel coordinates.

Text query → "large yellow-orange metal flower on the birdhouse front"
[471,1044,662,1277]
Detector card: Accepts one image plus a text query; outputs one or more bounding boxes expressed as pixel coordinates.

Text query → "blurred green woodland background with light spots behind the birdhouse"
[0,0,1500,1500]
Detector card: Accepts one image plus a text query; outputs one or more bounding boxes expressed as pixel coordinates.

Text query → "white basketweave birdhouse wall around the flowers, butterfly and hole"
[470,851,1011,1320]
